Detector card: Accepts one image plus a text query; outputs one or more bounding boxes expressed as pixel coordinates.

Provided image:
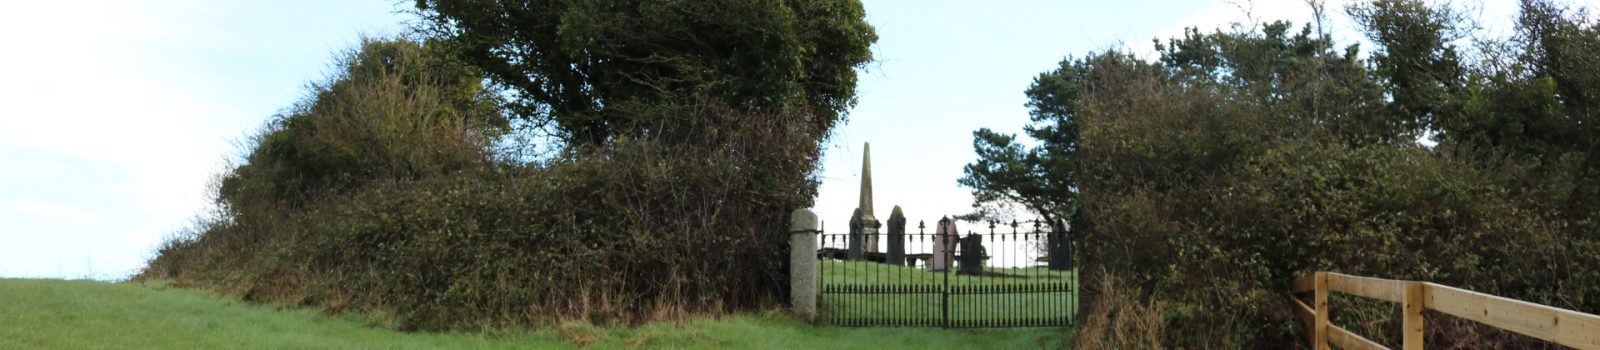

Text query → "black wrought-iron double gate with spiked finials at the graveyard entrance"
[818,219,1078,328]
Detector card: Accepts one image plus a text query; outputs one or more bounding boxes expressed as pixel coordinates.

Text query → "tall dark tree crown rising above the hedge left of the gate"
[416,0,877,147]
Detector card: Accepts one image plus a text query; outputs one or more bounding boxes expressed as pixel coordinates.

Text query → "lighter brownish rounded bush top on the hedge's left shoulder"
[218,40,507,206]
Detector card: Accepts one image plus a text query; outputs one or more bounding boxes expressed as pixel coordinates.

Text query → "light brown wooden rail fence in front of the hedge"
[1291,272,1600,350]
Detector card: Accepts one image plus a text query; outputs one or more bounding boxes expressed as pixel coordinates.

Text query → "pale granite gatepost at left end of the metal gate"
[789,209,819,321]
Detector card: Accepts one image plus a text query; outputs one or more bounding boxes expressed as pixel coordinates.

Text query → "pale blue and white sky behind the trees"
[0,0,1580,280]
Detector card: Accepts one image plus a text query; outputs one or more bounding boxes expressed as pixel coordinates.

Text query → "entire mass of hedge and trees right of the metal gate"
[1004,0,1600,348]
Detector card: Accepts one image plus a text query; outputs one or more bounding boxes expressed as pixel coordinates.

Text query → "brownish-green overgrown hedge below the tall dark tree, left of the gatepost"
[139,40,826,329]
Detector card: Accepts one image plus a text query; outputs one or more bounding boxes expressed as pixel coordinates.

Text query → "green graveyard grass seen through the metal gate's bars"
[821,261,1077,324]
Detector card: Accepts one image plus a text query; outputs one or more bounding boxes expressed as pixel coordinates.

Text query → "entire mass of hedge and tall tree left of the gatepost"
[139,0,877,329]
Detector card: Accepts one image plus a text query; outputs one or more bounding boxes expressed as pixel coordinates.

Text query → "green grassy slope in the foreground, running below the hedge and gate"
[0,280,1067,350]
